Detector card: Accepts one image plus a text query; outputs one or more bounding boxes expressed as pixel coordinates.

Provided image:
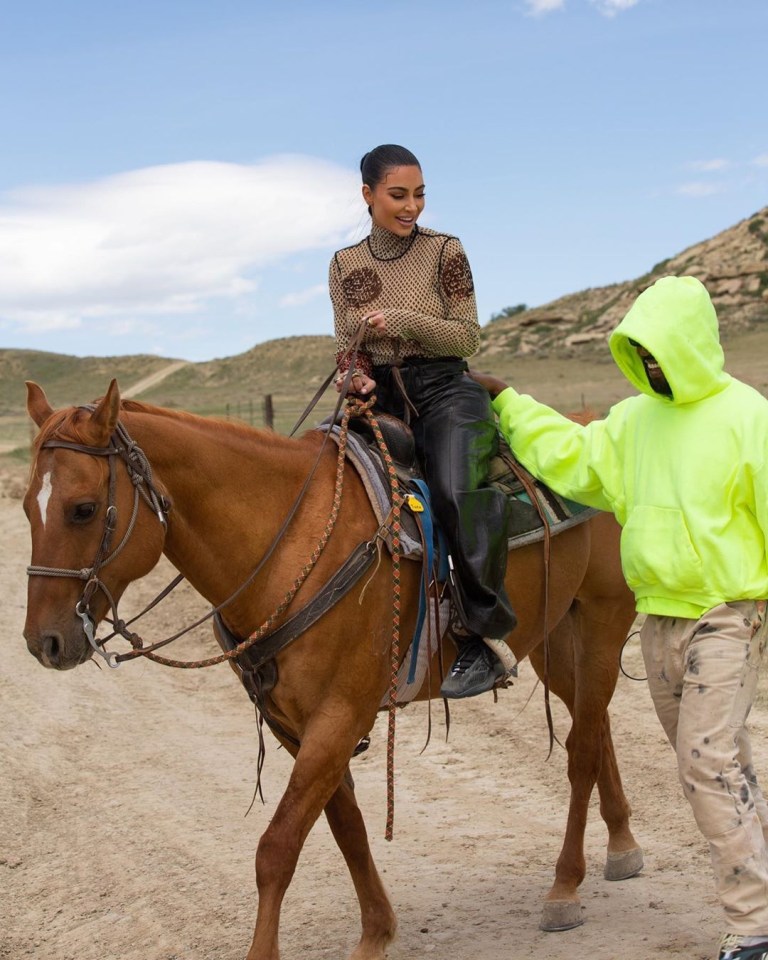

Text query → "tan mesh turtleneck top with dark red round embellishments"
[329,224,480,375]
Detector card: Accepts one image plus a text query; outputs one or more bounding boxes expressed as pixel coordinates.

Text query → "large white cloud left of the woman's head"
[0,156,360,331]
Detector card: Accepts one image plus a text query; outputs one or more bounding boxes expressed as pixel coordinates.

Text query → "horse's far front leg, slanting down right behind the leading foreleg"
[325,769,396,960]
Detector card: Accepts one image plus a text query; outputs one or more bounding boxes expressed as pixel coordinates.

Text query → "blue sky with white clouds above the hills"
[0,0,768,360]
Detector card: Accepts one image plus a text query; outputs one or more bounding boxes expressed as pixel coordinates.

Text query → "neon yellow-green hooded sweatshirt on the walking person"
[493,277,768,619]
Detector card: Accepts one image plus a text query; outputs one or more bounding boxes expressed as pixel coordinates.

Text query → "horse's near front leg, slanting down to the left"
[246,707,367,960]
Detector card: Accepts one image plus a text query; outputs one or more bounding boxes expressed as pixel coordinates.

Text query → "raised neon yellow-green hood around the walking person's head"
[608,277,731,404]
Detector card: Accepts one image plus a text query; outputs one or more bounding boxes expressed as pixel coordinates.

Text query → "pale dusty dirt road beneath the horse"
[0,488,744,960]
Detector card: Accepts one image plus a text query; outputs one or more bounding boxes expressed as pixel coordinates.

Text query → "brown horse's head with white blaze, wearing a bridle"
[24,380,165,670]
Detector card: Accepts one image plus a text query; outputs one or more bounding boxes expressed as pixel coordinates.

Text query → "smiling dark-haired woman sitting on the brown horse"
[329,144,516,698]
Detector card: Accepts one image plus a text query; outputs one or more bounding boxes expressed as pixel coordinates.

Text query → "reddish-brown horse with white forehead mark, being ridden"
[24,381,642,960]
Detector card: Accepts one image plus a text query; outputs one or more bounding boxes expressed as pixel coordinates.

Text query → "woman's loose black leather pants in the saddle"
[373,357,516,637]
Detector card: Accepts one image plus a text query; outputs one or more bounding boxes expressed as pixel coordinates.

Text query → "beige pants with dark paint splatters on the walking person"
[640,600,768,936]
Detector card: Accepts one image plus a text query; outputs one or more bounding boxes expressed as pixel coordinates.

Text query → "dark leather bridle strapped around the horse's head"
[27,412,171,668]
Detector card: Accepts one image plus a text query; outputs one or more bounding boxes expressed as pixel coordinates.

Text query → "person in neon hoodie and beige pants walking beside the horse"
[472,277,768,960]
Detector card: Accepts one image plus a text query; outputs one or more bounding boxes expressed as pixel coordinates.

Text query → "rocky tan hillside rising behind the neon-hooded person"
[478,207,768,366]
